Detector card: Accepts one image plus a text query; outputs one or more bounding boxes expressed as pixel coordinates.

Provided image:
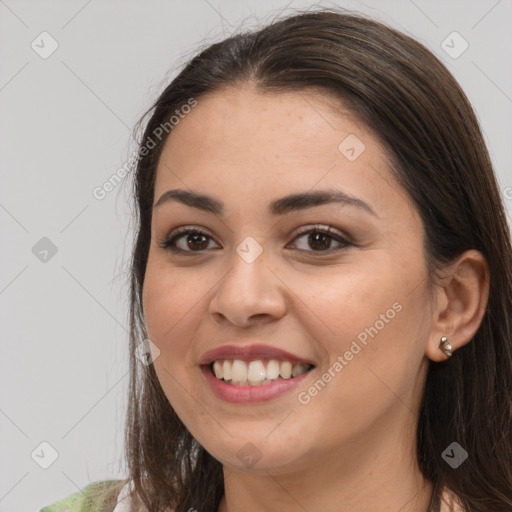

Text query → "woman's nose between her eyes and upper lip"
[209,243,287,327]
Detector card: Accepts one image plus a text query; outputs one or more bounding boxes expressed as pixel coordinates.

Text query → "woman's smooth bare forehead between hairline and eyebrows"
[155,87,410,218]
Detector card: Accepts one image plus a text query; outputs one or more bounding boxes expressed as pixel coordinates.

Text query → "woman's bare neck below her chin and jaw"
[218,412,433,512]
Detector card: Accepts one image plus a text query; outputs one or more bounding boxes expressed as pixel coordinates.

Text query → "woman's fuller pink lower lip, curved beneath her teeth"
[201,365,311,403]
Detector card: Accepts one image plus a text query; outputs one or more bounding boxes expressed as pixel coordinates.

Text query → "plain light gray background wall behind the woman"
[0,0,512,512]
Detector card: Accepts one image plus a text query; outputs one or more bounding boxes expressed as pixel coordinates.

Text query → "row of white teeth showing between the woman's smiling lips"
[208,359,315,386]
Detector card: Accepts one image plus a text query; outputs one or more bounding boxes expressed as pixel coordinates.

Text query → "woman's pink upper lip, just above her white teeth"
[199,344,314,366]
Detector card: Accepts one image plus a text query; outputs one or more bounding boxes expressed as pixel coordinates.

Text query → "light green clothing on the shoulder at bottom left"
[39,480,127,512]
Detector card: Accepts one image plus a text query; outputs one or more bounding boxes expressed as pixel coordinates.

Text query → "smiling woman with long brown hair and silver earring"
[43,5,512,512]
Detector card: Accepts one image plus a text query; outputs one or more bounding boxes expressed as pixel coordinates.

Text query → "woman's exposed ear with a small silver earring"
[425,250,490,362]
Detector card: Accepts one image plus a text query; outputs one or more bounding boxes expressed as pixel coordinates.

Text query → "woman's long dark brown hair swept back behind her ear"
[119,8,512,512]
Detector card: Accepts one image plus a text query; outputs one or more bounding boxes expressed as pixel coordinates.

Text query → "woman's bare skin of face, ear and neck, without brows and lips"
[143,84,489,512]
